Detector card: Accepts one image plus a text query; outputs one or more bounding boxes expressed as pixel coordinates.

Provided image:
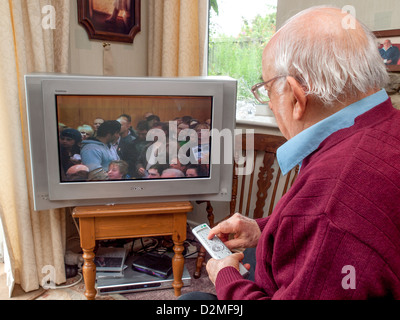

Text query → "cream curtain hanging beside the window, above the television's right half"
[148,0,208,77]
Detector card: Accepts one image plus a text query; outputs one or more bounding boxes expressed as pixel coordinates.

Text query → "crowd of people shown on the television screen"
[59,113,210,181]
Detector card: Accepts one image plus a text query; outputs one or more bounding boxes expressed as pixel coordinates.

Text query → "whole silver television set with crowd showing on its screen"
[25,74,237,211]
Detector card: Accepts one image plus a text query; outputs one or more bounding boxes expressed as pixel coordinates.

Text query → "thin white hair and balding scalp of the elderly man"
[272,7,388,106]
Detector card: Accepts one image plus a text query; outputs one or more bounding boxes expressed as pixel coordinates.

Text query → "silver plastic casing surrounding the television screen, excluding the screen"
[25,74,236,211]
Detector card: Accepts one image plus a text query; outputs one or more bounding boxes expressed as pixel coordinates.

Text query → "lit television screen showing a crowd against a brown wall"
[56,95,213,183]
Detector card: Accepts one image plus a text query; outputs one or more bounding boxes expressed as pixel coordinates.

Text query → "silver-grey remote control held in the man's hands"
[192,223,249,278]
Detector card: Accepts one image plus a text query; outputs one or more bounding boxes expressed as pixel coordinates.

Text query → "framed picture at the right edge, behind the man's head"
[374,29,400,72]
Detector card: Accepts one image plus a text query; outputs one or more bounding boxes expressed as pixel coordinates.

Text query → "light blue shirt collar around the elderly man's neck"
[276,89,389,175]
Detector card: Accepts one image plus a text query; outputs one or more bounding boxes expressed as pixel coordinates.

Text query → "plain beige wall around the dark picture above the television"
[70,0,148,77]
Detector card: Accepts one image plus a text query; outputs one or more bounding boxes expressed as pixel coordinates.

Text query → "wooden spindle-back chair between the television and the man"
[194,134,299,279]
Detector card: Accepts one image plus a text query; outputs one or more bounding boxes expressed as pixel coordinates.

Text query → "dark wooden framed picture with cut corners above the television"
[77,0,141,43]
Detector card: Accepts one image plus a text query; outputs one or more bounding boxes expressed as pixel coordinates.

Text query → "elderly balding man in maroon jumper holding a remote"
[184,7,400,299]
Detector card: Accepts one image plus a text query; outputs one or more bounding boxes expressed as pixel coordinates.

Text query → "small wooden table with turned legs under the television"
[72,201,193,300]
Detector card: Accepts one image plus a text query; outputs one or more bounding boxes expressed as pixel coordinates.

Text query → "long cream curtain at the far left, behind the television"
[0,0,70,292]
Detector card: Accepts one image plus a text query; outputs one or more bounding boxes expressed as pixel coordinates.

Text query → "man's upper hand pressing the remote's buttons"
[208,213,261,250]
